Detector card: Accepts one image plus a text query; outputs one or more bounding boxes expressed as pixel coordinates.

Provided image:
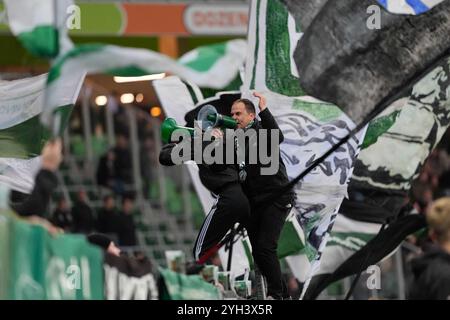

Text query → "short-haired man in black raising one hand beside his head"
[231,92,294,299]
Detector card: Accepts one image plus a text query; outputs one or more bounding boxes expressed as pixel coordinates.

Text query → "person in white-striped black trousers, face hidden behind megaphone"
[159,122,250,264]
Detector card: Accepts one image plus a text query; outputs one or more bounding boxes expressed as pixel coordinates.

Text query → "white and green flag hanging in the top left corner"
[4,0,73,58]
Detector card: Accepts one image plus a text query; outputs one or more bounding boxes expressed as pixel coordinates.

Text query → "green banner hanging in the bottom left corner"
[0,212,104,300]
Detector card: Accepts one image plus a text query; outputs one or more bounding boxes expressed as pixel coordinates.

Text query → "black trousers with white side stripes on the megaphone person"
[193,182,250,262]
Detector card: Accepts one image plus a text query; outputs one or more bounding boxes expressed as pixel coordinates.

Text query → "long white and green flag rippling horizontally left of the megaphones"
[42,40,246,125]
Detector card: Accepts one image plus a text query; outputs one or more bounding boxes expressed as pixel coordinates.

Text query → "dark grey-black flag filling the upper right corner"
[284,0,450,124]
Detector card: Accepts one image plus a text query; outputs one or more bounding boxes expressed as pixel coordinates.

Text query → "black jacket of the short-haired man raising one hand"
[242,108,294,203]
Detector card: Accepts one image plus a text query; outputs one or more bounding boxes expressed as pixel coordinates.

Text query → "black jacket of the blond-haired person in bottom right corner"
[409,247,450,300]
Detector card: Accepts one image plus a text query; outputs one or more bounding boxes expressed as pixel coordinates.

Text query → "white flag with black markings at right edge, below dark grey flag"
[350,58,450,195]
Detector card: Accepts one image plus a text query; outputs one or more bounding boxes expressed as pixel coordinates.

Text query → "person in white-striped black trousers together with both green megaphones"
[159,105,250,264]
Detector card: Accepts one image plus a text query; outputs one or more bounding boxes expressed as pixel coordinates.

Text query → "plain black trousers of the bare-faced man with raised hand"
[246,195,293,299]
